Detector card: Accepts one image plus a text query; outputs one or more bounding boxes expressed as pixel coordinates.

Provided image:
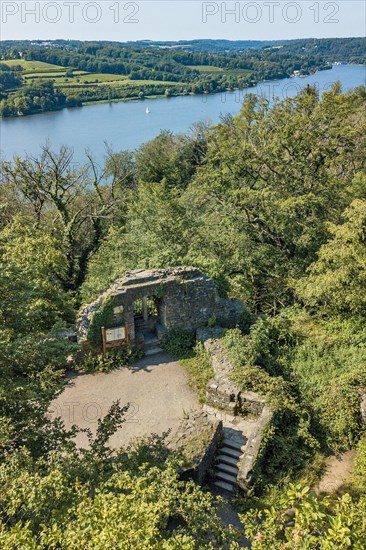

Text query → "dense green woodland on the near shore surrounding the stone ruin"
[0,84,366,550]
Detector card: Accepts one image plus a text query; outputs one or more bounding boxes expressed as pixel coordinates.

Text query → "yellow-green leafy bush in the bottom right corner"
[241,484,366,550]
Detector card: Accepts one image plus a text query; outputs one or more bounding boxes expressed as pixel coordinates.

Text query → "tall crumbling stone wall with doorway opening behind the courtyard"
[77,267,245,348]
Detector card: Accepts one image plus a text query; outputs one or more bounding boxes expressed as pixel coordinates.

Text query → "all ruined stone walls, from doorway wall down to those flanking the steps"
[77,267,271,490]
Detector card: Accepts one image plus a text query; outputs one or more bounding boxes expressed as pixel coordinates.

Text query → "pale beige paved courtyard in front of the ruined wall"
[50,354,200,448]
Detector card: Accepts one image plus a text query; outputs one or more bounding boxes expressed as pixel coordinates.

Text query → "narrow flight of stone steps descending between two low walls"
[214,428,246,493]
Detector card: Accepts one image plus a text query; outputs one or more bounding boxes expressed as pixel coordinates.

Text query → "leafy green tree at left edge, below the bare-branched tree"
[0,217,73,336]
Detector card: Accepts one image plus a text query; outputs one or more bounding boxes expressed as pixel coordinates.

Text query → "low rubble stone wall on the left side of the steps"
[171,411,223,485]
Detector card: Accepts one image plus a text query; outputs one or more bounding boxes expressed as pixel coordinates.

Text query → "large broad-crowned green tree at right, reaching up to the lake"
[185,88,365,312]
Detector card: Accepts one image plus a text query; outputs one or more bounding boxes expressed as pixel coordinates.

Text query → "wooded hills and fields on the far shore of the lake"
[0,38,366,116]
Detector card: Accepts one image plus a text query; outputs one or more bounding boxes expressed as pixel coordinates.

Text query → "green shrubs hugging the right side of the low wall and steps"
[222,326,319,489]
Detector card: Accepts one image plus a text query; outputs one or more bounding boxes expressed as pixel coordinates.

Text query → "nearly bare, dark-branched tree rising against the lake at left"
[2,146,129,290]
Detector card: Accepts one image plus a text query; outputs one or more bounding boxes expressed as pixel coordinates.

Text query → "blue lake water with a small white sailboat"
[0,65,366,162]
